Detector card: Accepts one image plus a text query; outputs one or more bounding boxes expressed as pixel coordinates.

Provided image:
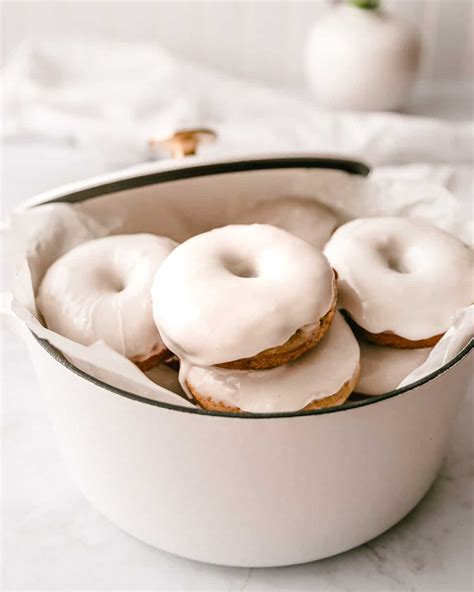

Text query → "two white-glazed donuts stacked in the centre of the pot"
[152,224,359,413]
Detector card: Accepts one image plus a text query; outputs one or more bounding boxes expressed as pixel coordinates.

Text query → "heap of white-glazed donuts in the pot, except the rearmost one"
[37,212,473,413]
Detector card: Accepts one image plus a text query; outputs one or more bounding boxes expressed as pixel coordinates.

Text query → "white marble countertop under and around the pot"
[1,86,474,592]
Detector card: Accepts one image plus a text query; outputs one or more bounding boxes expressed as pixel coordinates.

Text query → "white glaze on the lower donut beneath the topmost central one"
[179,312,359,413]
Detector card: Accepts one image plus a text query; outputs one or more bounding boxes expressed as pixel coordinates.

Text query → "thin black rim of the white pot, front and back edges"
[30,155,474,419]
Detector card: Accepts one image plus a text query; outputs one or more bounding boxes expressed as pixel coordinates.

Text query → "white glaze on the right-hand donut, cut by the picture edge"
[324,218,473,341]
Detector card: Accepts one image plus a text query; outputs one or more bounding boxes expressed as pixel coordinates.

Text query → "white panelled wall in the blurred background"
[2,0,473,86]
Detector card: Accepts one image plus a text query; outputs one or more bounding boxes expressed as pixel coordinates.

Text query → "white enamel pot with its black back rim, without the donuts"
[7,157,473,567]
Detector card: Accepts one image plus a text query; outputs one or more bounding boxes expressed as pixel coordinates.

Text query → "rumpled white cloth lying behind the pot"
[3,40,474,176]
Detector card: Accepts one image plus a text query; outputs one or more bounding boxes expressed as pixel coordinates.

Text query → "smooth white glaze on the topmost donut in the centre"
[152,224,334,366]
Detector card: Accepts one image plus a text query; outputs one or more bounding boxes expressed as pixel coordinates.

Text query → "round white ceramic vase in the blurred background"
[305,0,420,111]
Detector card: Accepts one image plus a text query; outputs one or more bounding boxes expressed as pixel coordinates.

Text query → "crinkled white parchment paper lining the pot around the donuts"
[4,169,474,406]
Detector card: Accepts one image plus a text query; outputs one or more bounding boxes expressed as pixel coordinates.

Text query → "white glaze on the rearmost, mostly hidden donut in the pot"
[234,197,338,249]
